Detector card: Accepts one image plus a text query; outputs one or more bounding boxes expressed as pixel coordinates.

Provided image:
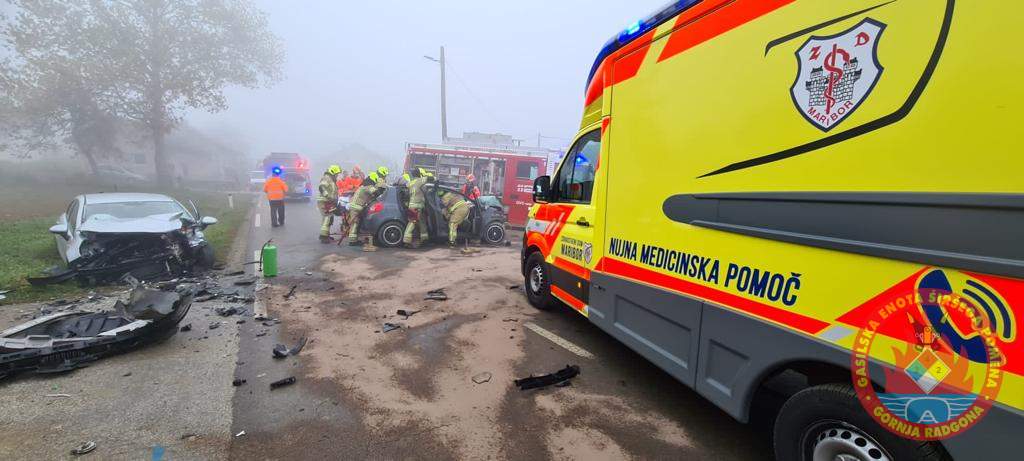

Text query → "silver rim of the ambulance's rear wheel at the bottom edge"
[803,421,893,461]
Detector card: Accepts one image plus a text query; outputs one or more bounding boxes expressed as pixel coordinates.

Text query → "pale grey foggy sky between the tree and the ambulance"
[186,0,665,159]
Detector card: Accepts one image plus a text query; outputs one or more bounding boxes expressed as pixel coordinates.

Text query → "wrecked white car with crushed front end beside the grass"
[29,194,217,284]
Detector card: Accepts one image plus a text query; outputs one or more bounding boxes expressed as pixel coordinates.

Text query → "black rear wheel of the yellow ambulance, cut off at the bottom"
[774,384,949,461]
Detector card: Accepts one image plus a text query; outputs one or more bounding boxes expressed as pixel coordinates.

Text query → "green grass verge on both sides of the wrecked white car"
[0,191,252,304]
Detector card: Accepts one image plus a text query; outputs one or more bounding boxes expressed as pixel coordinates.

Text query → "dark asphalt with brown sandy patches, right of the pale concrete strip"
[230,199,771,460]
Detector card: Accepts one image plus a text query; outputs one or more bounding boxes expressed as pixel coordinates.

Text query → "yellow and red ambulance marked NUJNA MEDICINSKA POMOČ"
[522,0,1024,460]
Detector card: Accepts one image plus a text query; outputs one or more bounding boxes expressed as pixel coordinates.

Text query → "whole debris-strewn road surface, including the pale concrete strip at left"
[0,196,771,460]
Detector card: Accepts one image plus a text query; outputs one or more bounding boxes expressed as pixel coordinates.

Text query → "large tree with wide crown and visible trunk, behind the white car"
[3,0,284,184]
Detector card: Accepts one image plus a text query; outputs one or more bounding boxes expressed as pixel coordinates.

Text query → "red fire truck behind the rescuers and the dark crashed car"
[406,142,547,227]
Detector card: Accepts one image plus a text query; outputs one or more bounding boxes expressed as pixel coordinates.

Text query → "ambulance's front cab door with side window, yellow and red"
[548,129,601,315]
